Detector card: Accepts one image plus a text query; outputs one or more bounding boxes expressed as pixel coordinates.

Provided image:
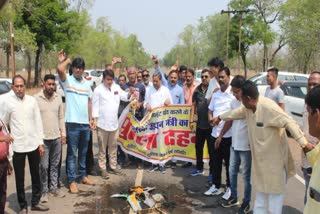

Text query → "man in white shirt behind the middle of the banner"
[145,72,173,173]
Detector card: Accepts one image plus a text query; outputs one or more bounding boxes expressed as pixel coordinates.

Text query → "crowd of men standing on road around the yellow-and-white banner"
[0,51,320,214]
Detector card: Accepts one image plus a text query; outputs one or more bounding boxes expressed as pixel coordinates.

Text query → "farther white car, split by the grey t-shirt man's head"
[249,71,309,96]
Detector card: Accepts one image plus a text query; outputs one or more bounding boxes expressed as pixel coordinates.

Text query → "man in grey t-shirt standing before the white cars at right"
[264,67,285,110]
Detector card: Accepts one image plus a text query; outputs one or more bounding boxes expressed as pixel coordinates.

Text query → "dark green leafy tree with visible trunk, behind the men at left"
[16,0,85,86]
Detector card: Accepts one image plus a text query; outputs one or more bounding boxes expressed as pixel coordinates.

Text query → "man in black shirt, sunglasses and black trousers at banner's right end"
[190,69,212,176]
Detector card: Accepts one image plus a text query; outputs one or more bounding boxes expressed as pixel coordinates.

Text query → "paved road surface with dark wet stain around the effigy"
[6,140,304,214]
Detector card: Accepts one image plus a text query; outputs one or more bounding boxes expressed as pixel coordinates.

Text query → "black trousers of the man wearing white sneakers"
[210,136,231,188]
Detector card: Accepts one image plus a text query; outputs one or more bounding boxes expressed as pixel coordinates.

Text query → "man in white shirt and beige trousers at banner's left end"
[92,70,134,179]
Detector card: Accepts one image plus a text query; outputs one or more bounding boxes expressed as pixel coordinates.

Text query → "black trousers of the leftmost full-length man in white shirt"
[13,148,41,209]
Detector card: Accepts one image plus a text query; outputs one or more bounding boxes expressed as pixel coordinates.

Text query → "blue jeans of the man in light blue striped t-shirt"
[66,123,90,183]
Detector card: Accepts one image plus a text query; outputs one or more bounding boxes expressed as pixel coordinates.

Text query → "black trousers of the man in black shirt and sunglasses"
[195,128,212,171]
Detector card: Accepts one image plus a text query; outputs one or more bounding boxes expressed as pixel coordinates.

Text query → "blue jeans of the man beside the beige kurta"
[229,146,251,203]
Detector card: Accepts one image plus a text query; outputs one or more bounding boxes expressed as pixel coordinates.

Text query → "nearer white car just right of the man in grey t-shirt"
[280,81,308,127]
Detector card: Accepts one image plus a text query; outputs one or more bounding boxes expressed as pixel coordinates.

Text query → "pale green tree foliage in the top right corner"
[281,0,320,73]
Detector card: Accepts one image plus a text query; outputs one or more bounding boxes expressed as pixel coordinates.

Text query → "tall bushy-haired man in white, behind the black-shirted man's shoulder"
[206,57,224,104]
